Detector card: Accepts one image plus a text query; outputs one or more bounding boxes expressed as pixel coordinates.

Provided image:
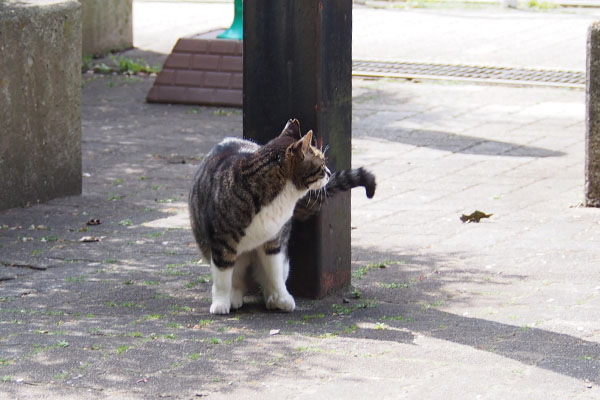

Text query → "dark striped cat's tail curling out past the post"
[294,167,377,221]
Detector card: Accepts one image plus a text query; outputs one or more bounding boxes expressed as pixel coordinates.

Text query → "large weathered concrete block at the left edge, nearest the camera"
[0,0,81,210]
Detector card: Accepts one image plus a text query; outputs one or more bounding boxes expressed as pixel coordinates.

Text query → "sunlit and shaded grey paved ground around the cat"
[0,1,600,400]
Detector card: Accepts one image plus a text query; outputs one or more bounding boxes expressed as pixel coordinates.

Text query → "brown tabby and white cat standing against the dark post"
[189,119,376,314]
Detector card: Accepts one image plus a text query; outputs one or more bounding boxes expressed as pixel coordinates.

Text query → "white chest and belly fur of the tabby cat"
[237,181,306,254]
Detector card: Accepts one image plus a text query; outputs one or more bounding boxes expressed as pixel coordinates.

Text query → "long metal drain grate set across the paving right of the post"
[352,60,585,88]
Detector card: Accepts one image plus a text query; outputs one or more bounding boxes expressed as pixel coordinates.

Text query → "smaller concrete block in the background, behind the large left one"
[79,0,133,56]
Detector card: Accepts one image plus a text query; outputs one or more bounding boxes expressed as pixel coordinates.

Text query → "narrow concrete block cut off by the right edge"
[585,22,600,207]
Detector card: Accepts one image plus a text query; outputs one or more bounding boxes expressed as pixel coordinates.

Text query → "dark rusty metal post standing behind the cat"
[243,0,352,298]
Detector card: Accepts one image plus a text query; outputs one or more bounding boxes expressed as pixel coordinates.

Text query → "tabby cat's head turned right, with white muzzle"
[281,120,331,190]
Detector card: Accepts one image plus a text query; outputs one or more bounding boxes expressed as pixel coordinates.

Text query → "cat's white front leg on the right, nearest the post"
[255,248,296,312]
